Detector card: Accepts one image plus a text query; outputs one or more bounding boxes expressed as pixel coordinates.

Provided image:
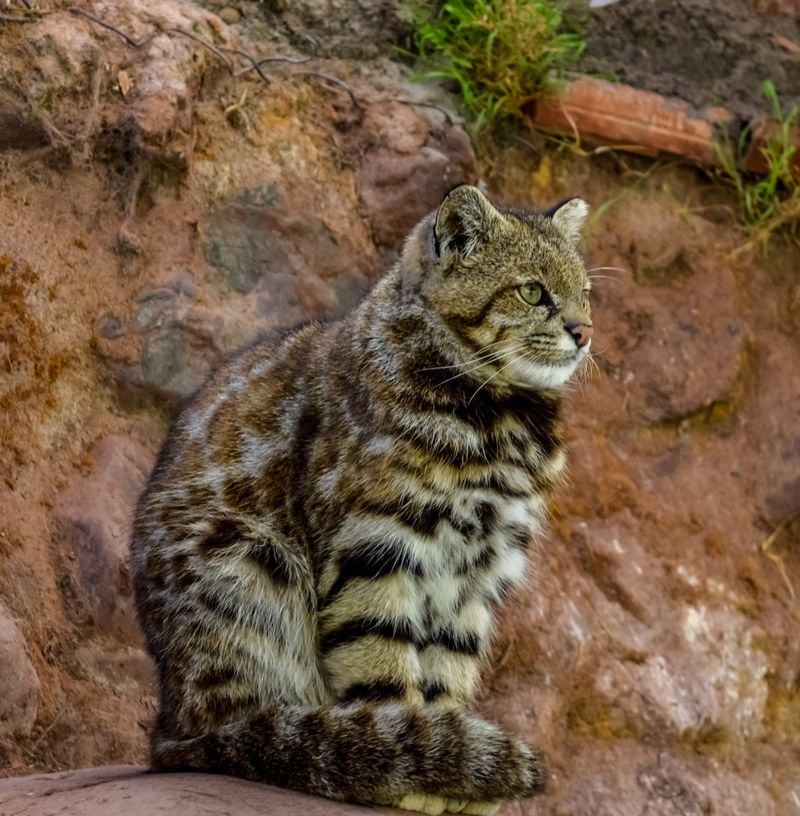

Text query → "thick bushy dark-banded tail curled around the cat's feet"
[152,703,545,804]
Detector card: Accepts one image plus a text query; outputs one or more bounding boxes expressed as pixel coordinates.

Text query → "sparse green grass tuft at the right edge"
[715,80,800,241]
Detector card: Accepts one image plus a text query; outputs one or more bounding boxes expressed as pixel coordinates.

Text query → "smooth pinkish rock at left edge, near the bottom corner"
[0,601,40,741]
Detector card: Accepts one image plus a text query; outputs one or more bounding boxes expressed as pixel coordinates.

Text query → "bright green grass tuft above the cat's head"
[408,0,586,128]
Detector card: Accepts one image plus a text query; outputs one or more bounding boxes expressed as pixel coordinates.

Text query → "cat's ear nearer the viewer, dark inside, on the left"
[433,184,504,258]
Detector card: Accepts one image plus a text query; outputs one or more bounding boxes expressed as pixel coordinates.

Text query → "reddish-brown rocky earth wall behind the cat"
[0,0,800,816]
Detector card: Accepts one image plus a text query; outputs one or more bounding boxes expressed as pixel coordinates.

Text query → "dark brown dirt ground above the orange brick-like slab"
[582,0,800,120]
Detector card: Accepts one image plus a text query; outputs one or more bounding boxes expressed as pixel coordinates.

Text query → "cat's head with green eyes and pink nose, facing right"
[402,185,592,389]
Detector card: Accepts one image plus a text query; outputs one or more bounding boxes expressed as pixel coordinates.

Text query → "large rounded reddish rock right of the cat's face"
[590,193,750,428]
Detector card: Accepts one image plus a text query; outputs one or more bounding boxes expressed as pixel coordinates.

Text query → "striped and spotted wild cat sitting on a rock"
[131,185,592,814]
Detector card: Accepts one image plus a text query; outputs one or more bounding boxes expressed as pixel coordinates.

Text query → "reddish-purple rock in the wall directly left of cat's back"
[53,436,152,642]
